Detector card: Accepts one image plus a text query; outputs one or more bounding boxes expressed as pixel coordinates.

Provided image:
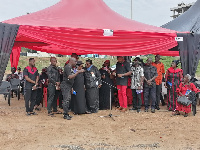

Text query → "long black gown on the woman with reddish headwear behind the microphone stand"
[99,68,113,110]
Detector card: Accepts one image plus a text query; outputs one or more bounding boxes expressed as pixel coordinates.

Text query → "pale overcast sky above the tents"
[0,0,196,26]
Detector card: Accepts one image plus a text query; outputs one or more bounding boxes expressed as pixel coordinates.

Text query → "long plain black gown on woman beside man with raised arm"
[72,73,86,114]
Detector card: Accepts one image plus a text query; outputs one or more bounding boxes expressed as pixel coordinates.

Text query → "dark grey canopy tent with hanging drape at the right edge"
[162,0,200,77]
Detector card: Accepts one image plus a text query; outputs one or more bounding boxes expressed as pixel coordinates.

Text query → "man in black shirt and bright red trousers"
[116,56,131,112]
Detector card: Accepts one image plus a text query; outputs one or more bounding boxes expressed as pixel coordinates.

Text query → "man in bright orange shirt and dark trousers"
[152,55,165,110]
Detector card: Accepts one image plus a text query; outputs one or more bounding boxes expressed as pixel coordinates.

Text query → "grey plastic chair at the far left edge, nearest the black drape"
[0,81,11,106]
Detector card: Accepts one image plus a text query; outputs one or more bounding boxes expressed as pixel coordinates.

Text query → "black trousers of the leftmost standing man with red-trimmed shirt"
[24,89,37,112]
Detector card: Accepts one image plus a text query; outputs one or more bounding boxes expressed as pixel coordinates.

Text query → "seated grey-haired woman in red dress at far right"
[174,74,200,117]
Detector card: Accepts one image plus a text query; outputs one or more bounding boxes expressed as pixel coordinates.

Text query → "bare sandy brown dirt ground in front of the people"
[0,96,200,150]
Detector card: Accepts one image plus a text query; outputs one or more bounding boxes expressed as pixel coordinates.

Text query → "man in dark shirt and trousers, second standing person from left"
[47,57,60,116]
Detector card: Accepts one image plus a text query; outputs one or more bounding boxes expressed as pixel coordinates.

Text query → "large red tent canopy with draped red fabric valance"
[4,0,177,67]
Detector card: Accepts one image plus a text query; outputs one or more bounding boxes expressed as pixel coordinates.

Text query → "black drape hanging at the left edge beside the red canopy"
[0,23,19,84]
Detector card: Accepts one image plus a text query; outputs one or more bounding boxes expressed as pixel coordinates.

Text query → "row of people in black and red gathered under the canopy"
[6,53,200,120]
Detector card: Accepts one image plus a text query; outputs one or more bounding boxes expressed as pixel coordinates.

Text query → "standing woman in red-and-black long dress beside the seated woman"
[165,60,183,111]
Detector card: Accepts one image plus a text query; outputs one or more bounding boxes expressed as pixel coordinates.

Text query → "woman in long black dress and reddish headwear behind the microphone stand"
[99,60,113,110]
